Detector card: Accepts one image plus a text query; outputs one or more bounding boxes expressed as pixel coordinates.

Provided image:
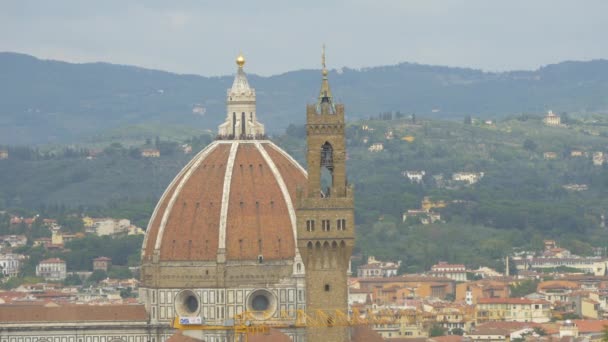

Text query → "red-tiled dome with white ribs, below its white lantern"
[142,140,306,263]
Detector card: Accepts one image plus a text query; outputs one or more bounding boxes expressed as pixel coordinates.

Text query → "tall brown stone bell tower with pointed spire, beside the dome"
[296,48,355,342]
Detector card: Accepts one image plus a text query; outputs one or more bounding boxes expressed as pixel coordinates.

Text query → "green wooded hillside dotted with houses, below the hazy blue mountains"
[0,116,608,271]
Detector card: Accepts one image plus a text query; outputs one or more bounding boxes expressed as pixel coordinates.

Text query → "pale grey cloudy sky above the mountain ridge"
[0,0,608,76]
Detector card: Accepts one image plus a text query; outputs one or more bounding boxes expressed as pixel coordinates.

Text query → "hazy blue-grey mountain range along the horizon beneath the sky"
[0,53,608,144]
